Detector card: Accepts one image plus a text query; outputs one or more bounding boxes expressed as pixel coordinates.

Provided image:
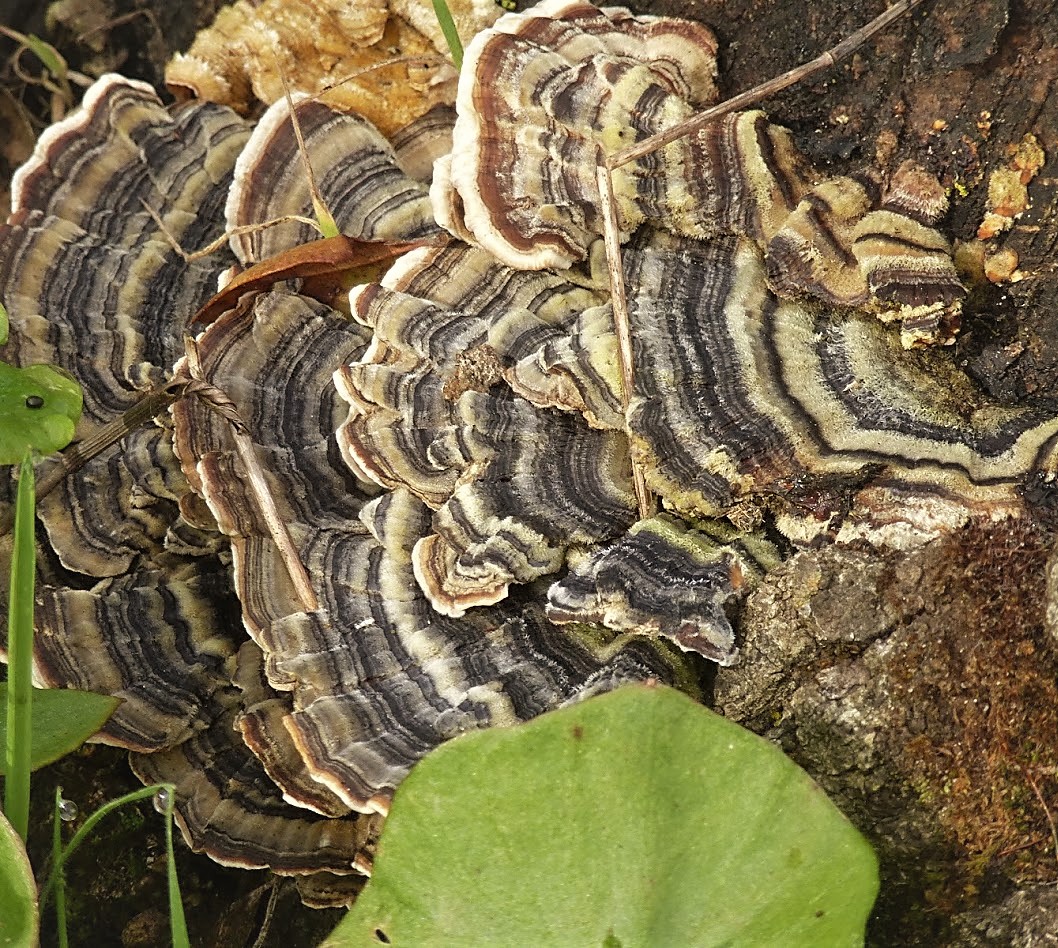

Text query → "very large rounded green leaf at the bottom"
[326,687,878,948]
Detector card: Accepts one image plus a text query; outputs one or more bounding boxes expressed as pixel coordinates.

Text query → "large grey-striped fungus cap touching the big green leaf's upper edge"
[174,280,674,813]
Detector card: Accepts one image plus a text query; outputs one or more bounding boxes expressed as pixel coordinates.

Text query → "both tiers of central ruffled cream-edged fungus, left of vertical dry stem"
[336,248,633,616]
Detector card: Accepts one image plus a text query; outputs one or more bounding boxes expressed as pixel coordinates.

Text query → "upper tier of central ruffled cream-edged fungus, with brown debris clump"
[335,245,603,507]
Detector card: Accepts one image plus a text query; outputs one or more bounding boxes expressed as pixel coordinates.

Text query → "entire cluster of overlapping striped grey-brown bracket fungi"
[0,0,1058,903]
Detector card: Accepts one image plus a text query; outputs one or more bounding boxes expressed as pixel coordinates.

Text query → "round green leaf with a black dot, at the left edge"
[0,362,83,464]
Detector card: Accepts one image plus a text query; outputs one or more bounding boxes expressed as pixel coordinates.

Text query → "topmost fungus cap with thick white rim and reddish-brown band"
[434,0,716,269]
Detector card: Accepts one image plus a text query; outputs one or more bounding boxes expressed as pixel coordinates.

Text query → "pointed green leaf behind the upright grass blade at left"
[0,682,122,778]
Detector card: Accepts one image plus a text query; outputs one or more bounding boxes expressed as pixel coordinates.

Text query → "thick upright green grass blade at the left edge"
[4,455,37,842]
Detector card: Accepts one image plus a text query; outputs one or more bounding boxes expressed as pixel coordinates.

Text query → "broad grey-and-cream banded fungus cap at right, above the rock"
[508,224,1058,540]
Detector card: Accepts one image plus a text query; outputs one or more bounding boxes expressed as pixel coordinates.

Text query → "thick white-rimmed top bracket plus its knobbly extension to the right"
[433,0,963,347]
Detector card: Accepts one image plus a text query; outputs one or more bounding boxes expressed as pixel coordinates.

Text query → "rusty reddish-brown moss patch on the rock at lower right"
[890,524,1058,910]
